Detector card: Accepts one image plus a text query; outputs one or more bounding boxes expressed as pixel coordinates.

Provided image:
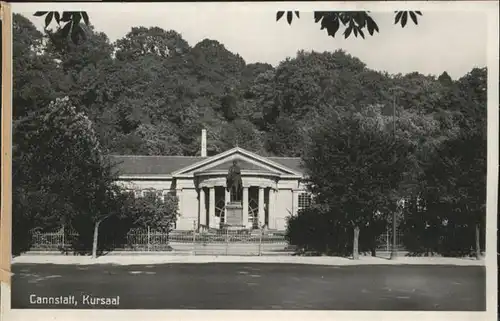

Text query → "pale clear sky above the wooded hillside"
[13,3,488,79]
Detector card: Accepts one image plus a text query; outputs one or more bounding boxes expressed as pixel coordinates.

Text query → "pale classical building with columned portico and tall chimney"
[110,131,311,230]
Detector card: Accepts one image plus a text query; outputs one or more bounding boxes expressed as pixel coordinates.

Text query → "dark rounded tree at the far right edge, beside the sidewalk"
[425,131,486,259]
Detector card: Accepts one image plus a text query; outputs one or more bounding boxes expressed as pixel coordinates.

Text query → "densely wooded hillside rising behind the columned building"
[14,15,486,156]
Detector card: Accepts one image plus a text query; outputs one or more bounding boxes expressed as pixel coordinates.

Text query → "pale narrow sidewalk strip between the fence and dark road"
[12,253,485,266]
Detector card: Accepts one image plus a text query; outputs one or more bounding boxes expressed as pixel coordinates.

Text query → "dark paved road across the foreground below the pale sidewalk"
[12,263,486,311]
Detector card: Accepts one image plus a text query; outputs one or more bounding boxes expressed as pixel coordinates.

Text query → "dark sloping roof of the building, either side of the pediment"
[108,155,303,175]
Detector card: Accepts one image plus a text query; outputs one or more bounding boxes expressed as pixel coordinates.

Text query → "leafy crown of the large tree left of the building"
[13,97,120,252]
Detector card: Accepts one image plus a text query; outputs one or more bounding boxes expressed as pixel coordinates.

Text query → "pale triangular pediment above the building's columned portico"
[173,147,301,176]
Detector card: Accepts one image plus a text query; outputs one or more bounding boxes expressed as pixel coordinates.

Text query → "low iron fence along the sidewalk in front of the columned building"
[31,224,405,255]
